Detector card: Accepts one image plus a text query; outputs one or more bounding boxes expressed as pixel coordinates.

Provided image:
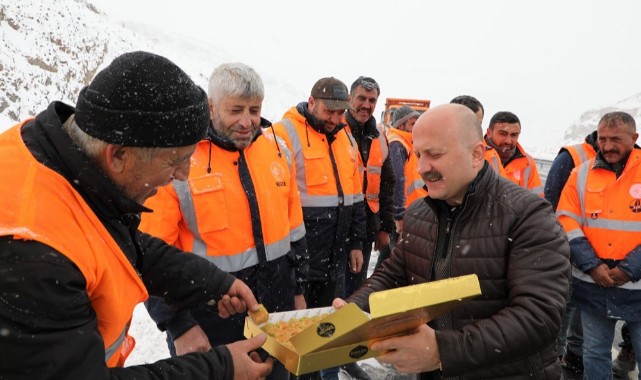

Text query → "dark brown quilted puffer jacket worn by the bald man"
[348,164,570,379]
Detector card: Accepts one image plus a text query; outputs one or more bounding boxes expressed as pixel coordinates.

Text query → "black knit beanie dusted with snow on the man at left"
[75,51,209,148]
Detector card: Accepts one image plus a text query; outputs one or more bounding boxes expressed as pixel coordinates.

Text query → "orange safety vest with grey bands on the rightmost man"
[557,149,641,260]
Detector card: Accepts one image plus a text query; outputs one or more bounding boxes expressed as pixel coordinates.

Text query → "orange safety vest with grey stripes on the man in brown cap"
[273,107,363,207]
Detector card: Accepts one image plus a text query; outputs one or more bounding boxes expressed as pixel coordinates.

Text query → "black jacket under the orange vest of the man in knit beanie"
[0,102,234,380]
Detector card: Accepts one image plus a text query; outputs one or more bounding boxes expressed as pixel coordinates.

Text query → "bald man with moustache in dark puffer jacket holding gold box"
[334,104,570,379]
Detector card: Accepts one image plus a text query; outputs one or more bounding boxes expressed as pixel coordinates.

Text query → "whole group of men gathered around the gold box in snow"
[0,52,641,379]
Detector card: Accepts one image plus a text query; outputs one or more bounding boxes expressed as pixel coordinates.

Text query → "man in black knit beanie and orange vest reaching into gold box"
[0,52,273,379]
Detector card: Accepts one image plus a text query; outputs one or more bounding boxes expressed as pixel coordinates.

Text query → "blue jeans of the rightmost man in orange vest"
[581,310,641,380]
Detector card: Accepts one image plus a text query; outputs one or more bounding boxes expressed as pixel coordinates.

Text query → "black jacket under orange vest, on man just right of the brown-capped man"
[345,112,396,242]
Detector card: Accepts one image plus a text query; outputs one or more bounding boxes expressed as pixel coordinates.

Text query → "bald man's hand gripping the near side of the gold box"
[371,325,441,373]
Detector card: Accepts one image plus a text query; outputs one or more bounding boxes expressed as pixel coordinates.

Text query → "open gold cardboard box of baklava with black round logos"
[245,274,481,375]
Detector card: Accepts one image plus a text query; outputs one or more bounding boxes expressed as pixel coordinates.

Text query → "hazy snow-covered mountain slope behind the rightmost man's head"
[563,92,641,144]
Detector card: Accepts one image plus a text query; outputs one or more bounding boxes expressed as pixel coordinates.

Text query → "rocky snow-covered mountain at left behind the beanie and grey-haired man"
[0,0,306,131]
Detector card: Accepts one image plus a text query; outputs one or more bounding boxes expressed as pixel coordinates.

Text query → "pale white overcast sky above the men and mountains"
[93,0,641,153]
